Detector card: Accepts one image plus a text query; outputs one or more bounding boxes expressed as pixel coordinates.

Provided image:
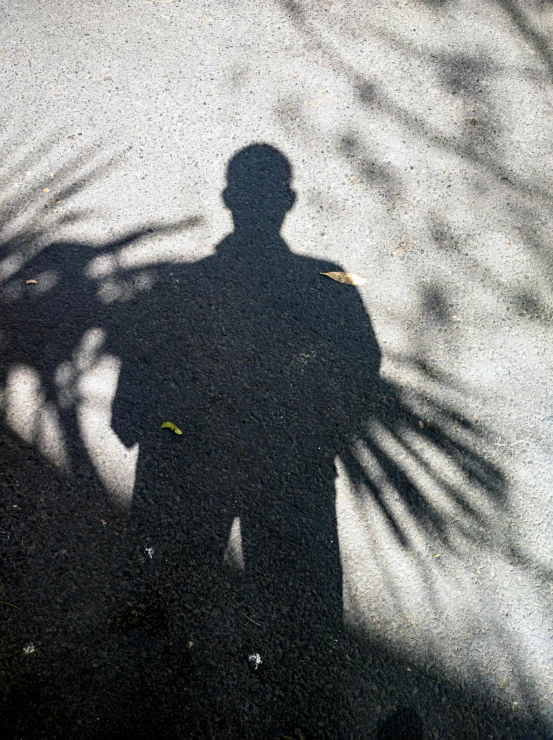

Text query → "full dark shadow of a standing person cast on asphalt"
[113,144,380,737]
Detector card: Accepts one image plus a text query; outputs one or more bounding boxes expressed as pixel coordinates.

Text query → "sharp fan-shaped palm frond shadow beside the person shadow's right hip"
[342,378,507,550]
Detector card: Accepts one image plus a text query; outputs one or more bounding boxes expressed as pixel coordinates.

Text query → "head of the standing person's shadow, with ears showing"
[223,144,296,238]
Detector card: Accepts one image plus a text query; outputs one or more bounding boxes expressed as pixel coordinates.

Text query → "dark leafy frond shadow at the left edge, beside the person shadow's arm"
[0,139,202,481]
